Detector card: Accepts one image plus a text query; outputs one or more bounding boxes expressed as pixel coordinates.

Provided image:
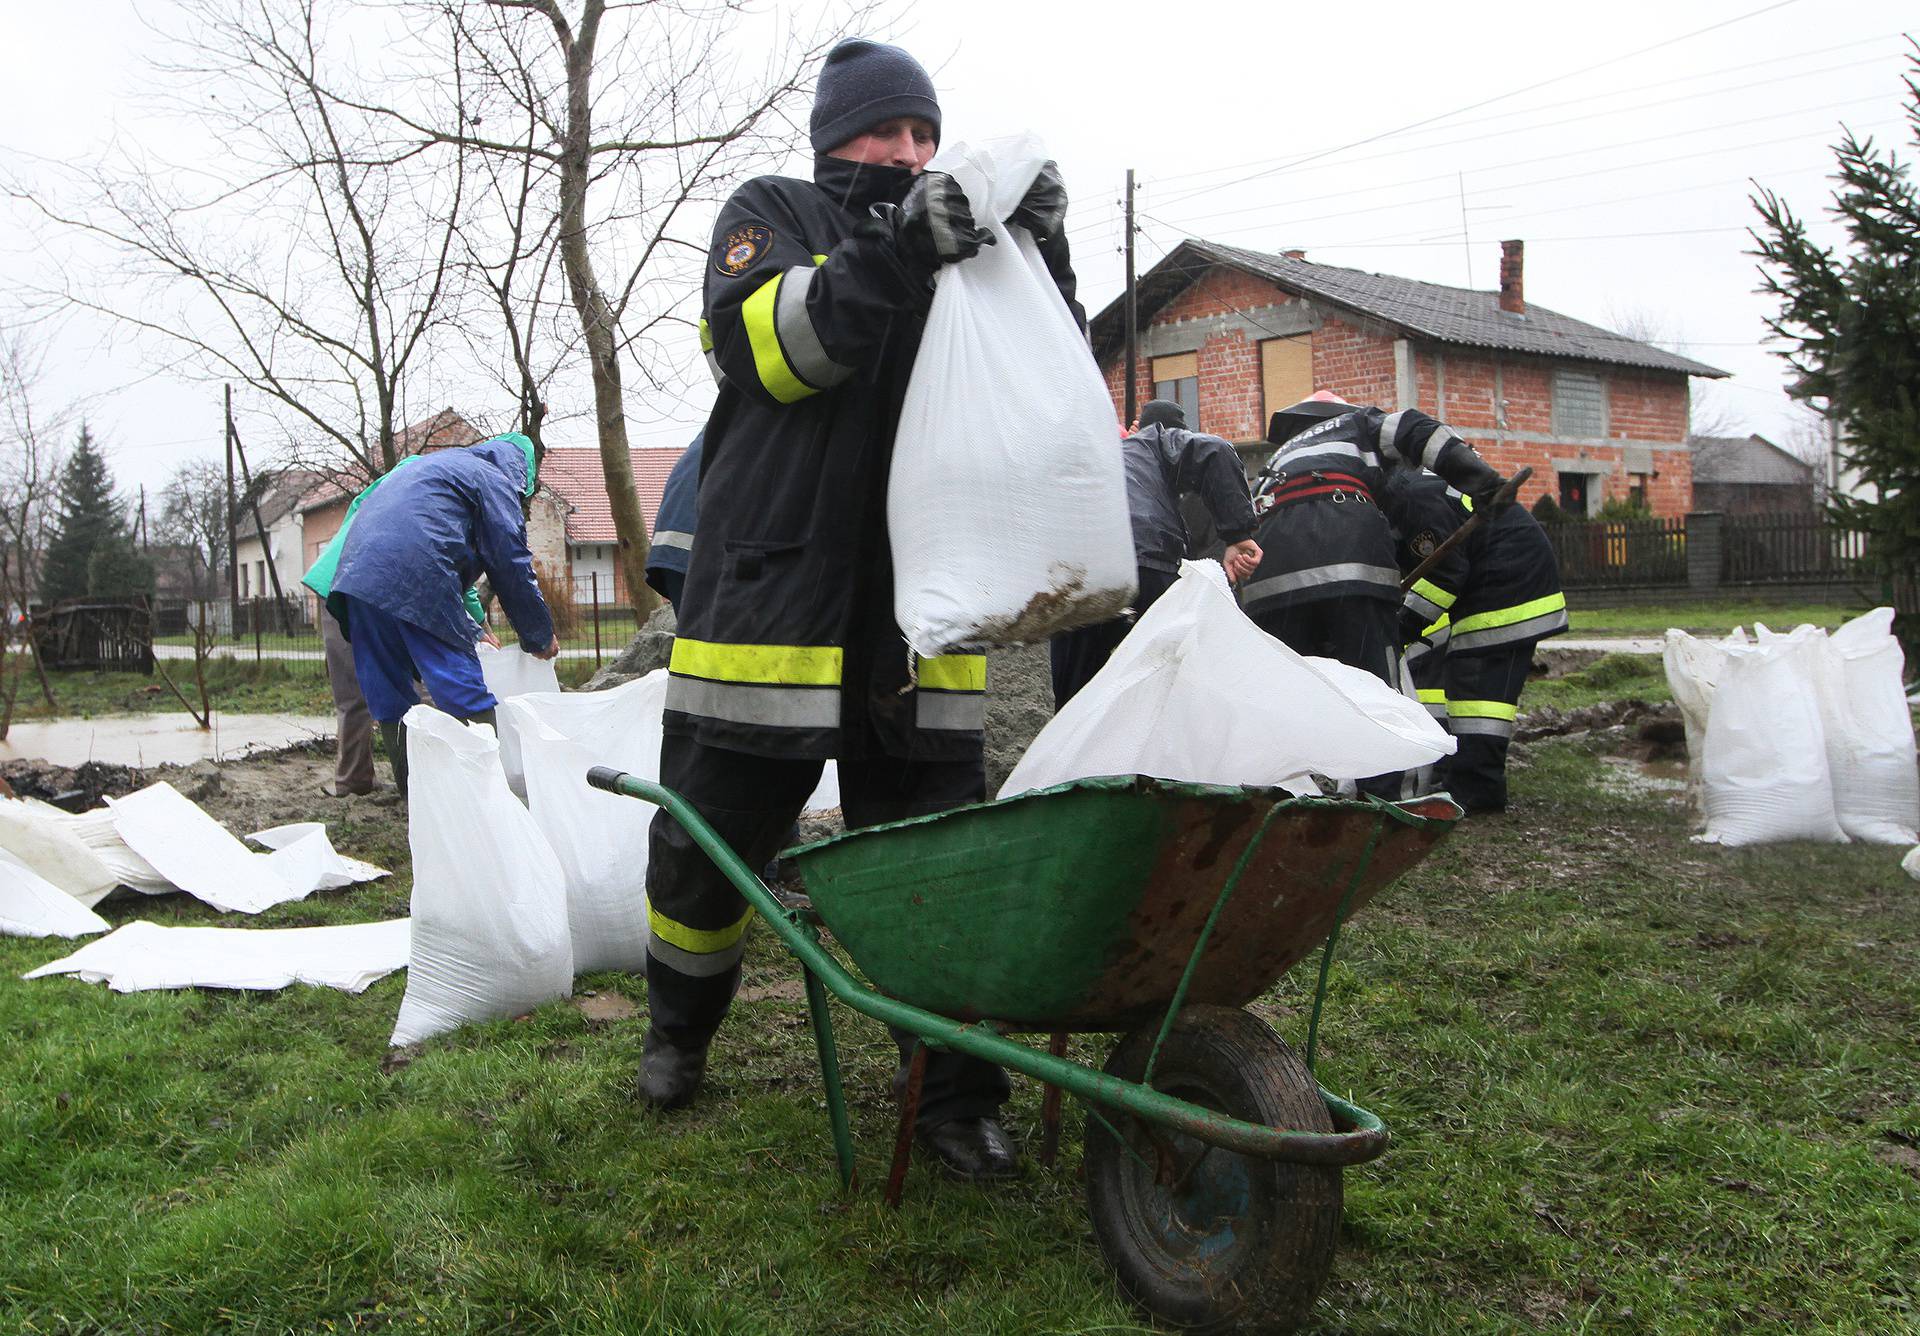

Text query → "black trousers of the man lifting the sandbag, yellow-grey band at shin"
[647,733,1010,1127]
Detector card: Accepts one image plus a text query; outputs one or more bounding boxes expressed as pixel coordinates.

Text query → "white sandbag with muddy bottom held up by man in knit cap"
[887,134,1135,655]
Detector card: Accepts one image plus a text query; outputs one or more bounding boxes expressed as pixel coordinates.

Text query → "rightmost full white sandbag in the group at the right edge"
[1820,608,1920,845]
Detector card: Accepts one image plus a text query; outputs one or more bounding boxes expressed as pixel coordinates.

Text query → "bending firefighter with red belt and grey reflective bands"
[1240,392,1501,797]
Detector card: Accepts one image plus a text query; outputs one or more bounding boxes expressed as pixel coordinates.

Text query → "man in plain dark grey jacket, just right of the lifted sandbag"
[1050,399,1260,710]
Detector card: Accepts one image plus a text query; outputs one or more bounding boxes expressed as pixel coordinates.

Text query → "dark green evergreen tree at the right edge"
[1753,42,1920,574]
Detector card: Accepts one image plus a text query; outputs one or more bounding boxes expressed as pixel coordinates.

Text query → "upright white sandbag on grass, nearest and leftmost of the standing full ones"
[392,704,574,1044]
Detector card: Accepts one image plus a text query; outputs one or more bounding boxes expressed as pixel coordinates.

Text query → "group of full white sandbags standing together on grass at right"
[1667,608,1920,845]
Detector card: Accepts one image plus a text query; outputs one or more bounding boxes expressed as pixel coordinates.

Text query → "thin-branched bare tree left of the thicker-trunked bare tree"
[6,0,467,478]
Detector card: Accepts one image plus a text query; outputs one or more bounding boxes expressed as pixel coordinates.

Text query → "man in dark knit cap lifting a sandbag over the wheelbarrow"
[641,40,1085,1179]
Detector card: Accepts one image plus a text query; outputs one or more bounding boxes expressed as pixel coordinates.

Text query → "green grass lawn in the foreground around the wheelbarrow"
[0,743,1920,1336]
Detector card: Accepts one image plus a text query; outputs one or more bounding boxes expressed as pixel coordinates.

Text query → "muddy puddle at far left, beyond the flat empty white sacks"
[0,710,334,770]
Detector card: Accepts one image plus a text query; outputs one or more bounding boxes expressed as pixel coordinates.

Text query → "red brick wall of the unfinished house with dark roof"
[1102,269,1693,514]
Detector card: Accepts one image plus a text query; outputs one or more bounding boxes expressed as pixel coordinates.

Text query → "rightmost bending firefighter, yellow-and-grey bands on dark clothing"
[1380,472,1567,812]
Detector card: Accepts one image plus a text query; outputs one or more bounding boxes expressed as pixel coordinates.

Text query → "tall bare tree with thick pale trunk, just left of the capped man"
[407,0,872,614]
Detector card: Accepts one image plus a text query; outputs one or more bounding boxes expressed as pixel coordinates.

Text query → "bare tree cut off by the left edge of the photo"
[0,330,63,739]
